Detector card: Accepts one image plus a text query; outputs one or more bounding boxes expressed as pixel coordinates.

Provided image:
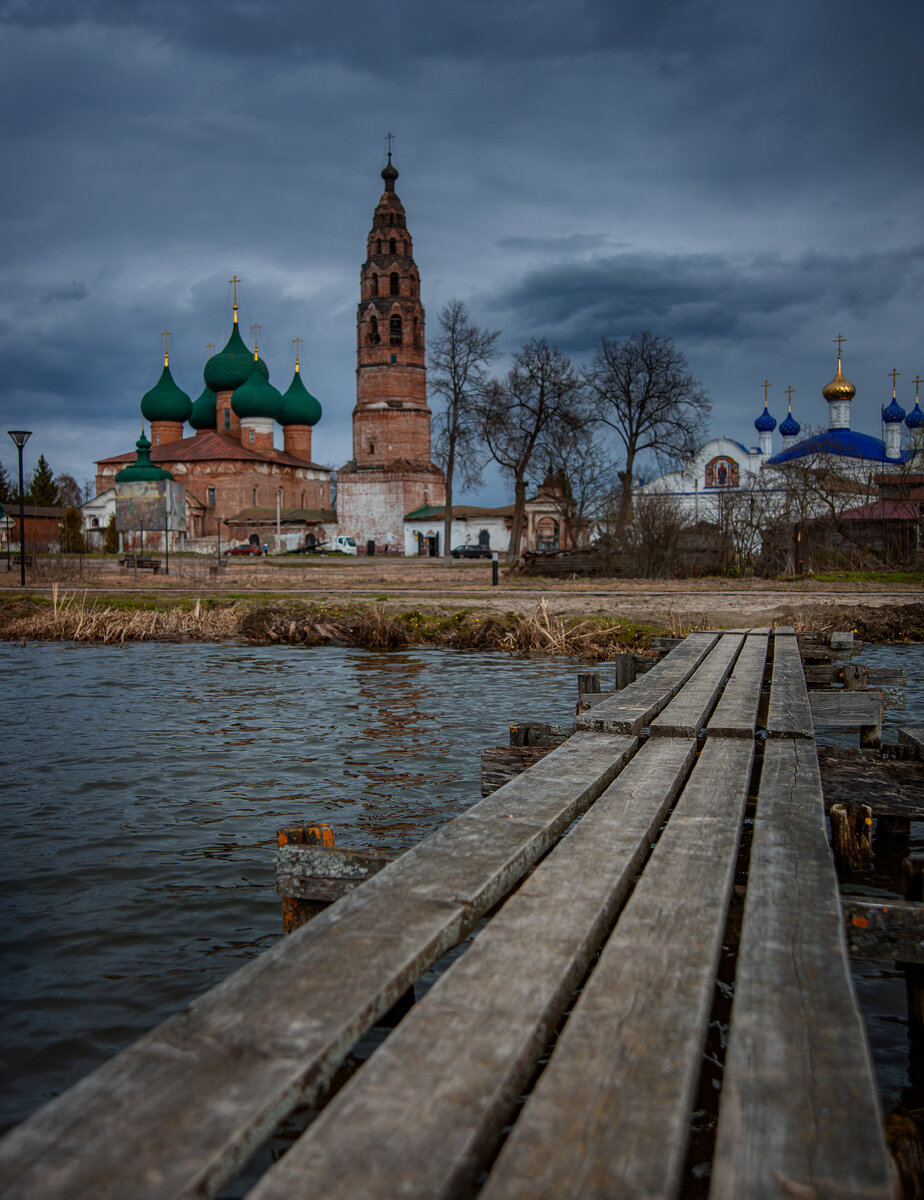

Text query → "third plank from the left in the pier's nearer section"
[480,738,754,1200]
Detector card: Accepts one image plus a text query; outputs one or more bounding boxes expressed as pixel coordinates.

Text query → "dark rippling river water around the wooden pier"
[0,643,924,1142]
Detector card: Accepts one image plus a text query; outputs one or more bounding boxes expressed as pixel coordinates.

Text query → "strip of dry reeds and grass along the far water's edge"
[0,589,924,661]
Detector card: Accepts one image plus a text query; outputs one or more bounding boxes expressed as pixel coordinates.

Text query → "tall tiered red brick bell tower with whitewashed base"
[337,150,445,552]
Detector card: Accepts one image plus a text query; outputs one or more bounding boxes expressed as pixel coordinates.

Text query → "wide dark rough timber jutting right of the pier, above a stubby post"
[818,746,924,821]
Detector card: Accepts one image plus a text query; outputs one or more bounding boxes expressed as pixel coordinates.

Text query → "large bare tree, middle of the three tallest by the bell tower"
[478,338,587,563]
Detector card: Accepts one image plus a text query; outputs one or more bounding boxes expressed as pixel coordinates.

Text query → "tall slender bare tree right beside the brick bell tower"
[430,298,500,566]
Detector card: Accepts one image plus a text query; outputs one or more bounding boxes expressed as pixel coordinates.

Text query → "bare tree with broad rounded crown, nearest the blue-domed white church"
[584,330,712,527]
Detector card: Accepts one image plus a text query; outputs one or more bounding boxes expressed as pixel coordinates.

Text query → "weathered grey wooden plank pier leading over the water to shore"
[0,630,924,1200]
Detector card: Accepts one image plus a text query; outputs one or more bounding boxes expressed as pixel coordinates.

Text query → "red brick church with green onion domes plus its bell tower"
[96,152,445,553]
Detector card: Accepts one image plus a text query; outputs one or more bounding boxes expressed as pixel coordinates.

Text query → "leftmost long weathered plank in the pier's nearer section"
[0,733,636,1200]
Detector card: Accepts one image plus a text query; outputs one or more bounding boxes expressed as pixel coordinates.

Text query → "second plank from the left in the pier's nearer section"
[251,738,695,1200]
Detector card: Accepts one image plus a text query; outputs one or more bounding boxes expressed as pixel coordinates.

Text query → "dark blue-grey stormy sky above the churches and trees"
[0,0,924,503]
